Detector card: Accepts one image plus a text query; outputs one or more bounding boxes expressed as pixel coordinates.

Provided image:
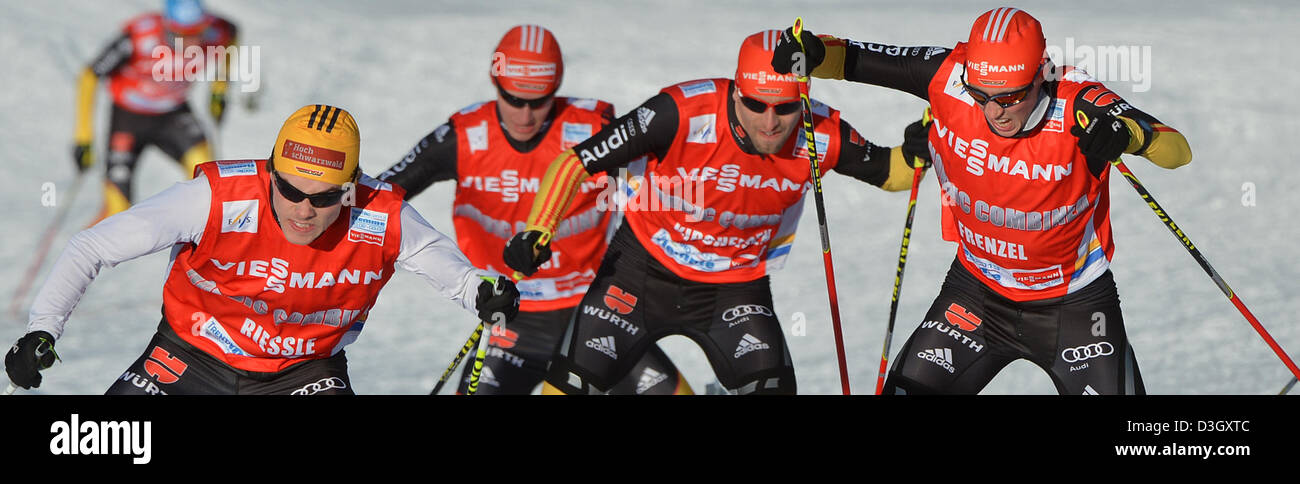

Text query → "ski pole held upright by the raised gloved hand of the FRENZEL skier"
[793,17,850,394]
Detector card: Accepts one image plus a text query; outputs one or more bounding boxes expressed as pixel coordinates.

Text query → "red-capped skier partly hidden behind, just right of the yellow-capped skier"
[380,25,690,394]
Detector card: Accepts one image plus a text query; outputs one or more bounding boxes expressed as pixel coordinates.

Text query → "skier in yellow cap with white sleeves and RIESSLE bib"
[5,104,519,394]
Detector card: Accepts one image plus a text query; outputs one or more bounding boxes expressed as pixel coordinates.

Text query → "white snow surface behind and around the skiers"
[0,0,1300,394]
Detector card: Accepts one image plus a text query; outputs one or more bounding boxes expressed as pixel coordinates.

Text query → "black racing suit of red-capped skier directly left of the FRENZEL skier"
[535,82,889,394]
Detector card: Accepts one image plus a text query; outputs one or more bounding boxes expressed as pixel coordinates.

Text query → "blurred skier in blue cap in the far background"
[73,0,245,221]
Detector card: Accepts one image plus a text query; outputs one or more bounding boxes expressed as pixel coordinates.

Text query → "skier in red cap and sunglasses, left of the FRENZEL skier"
[504,30,919,394]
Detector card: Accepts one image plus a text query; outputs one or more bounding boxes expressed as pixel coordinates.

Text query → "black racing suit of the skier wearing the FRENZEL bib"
[844,40,1158,394]
